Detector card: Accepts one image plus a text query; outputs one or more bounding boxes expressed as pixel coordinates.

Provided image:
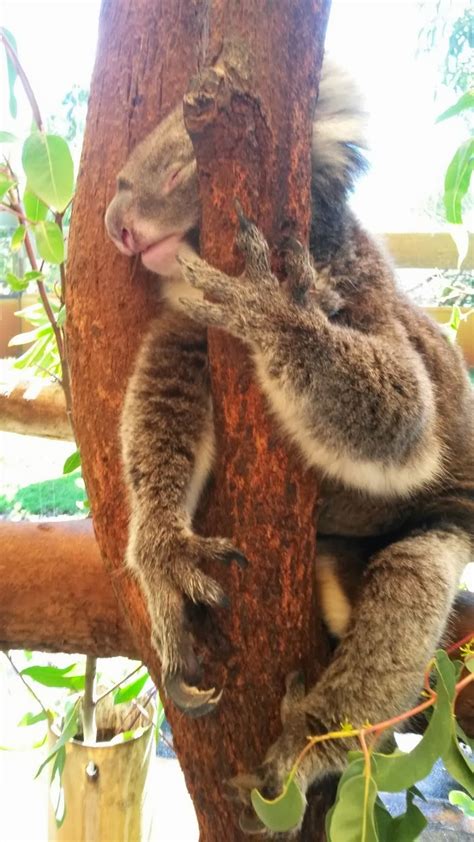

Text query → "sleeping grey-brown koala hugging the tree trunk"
[106,61,474,832]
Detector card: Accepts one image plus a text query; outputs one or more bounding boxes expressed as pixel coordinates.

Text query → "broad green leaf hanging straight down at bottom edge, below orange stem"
[329,761,379,842]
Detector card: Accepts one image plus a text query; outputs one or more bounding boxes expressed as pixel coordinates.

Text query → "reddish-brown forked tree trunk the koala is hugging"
[67,0,328,842]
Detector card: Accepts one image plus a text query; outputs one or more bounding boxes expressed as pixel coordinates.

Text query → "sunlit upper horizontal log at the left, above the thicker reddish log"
[0,371,73,441]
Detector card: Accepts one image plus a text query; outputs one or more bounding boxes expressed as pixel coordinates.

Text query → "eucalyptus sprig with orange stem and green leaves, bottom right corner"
[252,634,474,842]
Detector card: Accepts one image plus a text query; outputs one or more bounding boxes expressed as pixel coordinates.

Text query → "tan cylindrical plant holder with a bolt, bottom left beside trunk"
[48,700,155,842]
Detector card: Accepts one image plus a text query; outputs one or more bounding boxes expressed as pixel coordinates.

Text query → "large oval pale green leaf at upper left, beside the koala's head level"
[22,132,74,213]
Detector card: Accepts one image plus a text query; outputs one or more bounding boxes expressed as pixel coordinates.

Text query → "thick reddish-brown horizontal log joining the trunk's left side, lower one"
[0,520,137,658]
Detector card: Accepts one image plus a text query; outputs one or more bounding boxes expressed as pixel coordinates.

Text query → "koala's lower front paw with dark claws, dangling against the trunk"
[127,529,247,717]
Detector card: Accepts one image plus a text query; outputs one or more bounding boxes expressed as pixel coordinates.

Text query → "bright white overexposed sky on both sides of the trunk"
[0,0,465,231]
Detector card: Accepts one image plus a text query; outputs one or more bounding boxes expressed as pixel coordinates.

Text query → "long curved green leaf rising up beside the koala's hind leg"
[372,650,455,792]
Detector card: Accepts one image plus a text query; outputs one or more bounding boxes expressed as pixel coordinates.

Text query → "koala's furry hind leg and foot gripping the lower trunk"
[230,527,472,828]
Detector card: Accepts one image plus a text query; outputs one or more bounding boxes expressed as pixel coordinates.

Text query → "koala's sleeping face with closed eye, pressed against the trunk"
[105,105,199,276]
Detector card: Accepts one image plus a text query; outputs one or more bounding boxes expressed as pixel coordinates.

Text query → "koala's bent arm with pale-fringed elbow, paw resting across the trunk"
[179,218,441,496]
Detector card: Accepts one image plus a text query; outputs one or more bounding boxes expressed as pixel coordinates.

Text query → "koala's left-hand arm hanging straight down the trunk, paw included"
[121,312,244,716]
